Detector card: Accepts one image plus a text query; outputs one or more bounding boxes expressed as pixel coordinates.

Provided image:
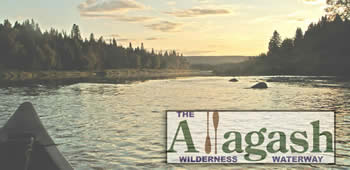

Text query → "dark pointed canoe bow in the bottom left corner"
[0,102,73,170]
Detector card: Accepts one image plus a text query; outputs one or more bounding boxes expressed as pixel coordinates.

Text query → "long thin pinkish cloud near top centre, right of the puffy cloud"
[165,8,231,17]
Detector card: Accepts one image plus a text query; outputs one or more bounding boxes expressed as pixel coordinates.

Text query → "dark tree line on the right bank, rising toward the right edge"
[215,0,350,76]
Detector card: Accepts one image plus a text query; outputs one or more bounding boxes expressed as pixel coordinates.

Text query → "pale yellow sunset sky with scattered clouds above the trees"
[0,0,326,56]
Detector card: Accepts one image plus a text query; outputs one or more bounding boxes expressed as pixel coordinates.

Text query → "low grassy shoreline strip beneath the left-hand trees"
[0,69,214,87]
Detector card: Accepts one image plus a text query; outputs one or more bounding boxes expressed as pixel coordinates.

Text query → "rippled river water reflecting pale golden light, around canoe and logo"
[0,76,350,169]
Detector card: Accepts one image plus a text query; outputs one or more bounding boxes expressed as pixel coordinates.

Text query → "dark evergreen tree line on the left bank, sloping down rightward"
[0,20,189,70]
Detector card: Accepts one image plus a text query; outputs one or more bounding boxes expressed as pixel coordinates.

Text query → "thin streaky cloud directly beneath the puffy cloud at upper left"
[81,14,154,22]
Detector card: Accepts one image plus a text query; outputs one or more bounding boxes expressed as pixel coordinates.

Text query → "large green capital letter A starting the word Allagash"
[168,120,199,152]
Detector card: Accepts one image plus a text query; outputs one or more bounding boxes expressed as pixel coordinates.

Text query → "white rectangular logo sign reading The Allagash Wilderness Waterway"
[166,110,335,164]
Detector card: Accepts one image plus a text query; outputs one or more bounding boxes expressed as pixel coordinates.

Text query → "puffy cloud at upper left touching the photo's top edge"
[78,0,146,13]
